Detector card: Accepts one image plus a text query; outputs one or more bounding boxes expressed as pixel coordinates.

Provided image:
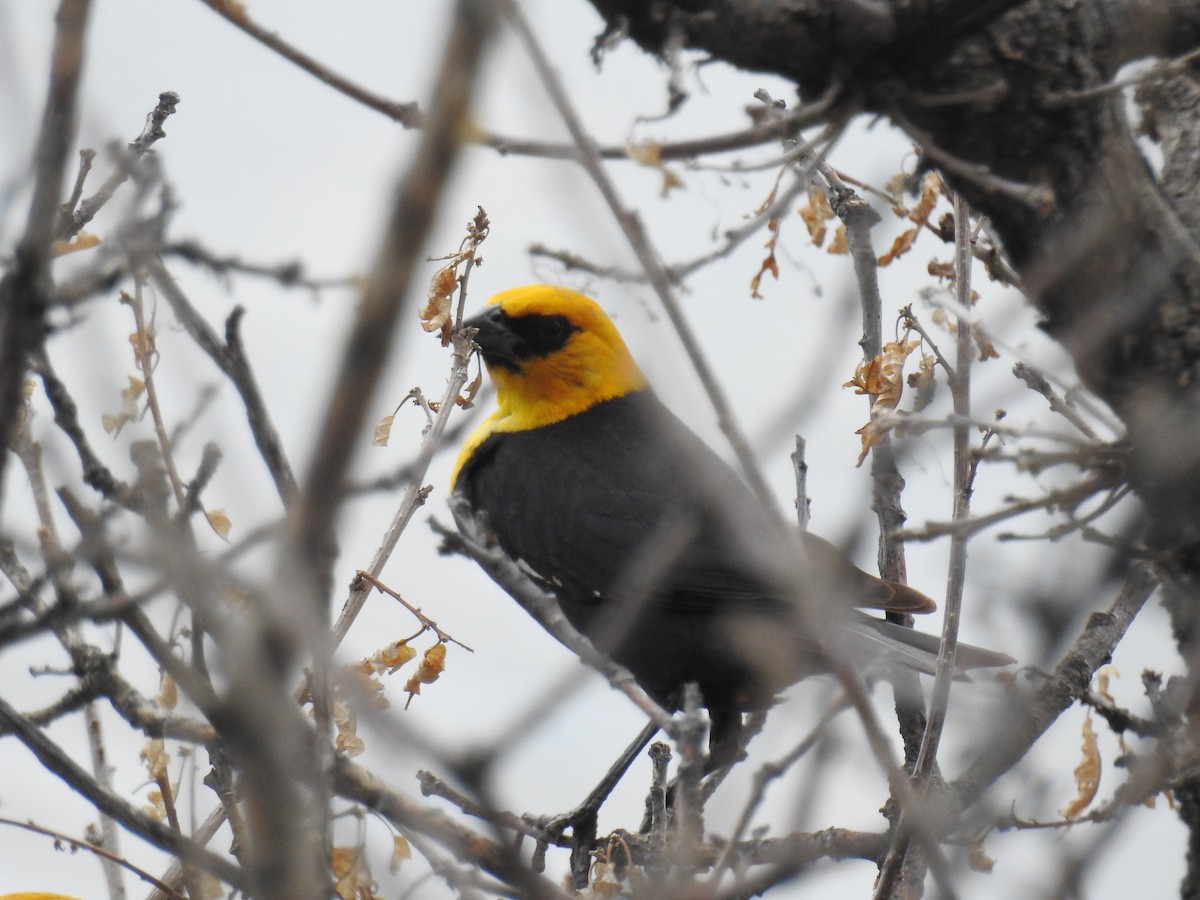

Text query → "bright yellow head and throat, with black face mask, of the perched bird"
[451,284,647,484]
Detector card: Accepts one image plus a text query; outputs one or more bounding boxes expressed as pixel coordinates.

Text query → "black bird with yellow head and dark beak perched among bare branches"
[451,284,1013,768]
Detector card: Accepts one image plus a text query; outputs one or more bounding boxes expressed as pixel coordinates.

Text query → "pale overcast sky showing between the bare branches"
[0,0,1184,898]
